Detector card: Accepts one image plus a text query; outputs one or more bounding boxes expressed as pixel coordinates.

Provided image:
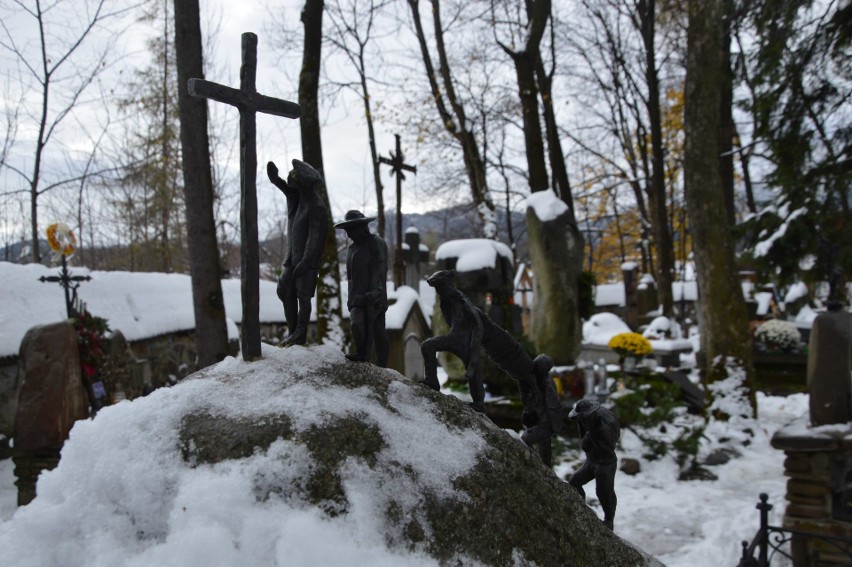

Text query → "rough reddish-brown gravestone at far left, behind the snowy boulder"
[12,321,89,506]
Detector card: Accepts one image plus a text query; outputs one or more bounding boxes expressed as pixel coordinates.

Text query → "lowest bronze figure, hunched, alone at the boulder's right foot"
[568,400,621,529]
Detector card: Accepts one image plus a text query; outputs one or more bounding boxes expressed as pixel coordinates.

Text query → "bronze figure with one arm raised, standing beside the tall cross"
[266,159,328,346]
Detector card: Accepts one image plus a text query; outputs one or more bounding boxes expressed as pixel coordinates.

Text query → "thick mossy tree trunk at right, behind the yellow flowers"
[684,0,756,407]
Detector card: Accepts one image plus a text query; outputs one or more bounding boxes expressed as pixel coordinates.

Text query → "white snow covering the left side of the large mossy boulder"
[0,345,483,567]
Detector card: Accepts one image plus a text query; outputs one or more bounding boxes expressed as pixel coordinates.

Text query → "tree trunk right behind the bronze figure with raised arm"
[299,0,342,342]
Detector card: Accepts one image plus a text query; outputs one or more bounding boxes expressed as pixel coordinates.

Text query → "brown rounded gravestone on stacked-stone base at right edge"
[808,303,852,426]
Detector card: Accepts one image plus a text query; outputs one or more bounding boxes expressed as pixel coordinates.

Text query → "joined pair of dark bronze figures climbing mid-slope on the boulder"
[421,270,564,466]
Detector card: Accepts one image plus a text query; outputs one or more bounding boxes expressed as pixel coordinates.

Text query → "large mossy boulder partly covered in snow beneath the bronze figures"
[0,345,659,566]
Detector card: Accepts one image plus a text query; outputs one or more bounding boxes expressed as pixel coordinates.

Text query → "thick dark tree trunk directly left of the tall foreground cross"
[174,0,228,368]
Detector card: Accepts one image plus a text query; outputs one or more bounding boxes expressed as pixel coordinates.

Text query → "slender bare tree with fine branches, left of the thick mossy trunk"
[573,0,674,316]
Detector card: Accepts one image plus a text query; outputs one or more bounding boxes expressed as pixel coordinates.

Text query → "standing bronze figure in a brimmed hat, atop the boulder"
[334,211,390,368]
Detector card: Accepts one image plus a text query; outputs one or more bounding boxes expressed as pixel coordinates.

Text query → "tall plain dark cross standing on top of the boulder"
[188,33,302,360]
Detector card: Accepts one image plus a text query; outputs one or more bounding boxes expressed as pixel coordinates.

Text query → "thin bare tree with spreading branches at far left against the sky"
[0,0,134,262]
